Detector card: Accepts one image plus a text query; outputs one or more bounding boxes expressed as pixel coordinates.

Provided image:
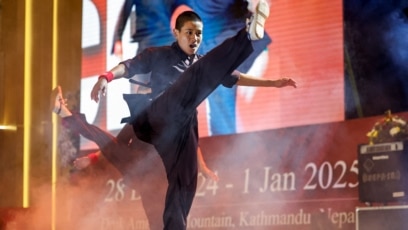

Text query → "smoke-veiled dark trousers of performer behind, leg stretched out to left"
[63,117,168,230]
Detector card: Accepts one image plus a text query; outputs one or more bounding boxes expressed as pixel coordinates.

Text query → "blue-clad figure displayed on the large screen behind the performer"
[112,0,271,135]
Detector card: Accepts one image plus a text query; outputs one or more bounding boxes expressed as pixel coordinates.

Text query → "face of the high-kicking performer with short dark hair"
[174,21,203,55]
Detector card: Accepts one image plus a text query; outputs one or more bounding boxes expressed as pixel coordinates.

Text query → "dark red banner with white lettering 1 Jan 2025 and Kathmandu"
[68,113,408,230]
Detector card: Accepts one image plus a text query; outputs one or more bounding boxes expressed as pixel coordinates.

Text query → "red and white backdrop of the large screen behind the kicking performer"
[81,0,345,149]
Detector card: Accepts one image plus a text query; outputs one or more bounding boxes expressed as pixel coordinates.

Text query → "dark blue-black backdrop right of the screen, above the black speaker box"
[343,0,408,119]
